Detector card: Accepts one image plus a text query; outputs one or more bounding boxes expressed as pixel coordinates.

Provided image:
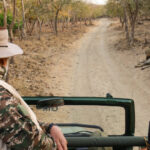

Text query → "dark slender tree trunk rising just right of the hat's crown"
[9,0,16,42]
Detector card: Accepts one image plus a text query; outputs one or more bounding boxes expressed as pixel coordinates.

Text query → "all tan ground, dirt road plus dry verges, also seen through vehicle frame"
[9,19,150,139]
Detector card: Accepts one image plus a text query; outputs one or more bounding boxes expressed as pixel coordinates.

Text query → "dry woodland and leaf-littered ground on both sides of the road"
[0,0,150,95]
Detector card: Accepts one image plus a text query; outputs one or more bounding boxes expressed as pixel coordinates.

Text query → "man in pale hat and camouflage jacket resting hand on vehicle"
[0,28,67,150]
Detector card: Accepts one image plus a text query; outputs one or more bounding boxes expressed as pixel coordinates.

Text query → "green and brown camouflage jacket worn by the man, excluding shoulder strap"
[0,86,54,150]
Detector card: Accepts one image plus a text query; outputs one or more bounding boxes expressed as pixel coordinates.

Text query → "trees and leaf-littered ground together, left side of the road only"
[0,0,104,96]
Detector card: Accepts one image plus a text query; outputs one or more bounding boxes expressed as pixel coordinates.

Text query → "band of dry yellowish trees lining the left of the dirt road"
[0,0,103,41]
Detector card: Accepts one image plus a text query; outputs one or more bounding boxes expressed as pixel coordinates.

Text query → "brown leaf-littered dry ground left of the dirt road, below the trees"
[8,23,94,96]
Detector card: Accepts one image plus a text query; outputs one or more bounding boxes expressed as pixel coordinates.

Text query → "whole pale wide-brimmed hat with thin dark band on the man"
[0,29,23,58]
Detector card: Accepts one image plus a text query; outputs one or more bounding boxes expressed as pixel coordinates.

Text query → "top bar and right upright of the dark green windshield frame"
[23,96,135,136]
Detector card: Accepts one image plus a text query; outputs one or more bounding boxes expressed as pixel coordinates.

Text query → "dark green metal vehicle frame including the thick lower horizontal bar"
[23,94,145,150]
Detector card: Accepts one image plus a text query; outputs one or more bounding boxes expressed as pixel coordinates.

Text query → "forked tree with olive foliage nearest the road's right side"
[107,0,139,45]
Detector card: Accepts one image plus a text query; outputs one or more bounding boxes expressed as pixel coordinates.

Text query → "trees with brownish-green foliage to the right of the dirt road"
[106,0,150,46]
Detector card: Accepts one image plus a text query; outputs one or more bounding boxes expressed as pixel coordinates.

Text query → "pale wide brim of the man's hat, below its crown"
[0,43,23,58]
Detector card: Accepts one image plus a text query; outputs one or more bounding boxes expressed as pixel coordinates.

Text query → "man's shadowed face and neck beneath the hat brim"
[0,58,8,79]
